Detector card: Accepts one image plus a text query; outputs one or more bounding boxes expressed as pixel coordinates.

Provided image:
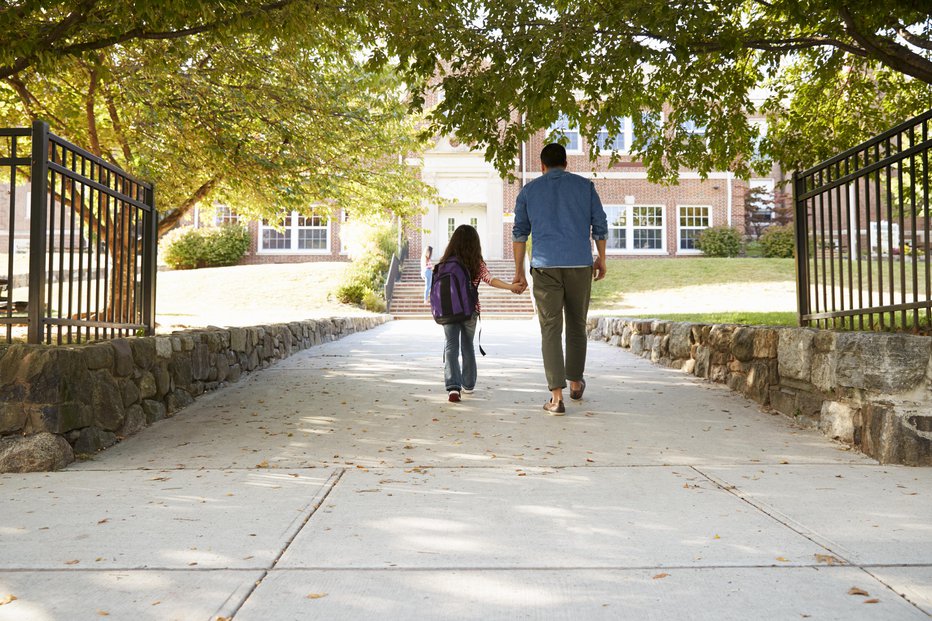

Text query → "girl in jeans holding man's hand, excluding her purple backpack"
[437,224,522,403]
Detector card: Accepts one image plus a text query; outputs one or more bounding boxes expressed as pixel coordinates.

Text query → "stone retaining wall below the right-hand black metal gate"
[589,317,932,466]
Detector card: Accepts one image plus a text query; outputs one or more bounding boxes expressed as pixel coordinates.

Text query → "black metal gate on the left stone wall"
[0,121,158,344]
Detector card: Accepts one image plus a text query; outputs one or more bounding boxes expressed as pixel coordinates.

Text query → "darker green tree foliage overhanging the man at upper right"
[366,0,932,180]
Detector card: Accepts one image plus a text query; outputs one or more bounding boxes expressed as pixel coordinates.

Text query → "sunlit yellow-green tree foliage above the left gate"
[0,1,430,233]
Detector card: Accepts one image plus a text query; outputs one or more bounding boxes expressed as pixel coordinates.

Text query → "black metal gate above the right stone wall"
[793,110,932,331]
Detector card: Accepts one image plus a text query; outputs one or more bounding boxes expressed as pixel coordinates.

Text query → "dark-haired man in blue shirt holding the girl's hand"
[512,143,608,416]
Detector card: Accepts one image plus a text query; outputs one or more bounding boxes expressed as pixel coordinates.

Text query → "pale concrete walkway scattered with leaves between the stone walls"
[0,321,932,621]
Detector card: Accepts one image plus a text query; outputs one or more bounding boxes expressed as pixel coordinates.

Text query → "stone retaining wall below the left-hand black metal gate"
[0,316,389,472]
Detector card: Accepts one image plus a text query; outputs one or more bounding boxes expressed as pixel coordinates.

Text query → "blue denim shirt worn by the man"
[512,168,608,267]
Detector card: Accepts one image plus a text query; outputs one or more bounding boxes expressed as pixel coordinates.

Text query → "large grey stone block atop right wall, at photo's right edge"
[835,332,932,394]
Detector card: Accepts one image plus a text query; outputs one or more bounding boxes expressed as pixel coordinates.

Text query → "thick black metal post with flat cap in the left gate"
[27,121,49,343]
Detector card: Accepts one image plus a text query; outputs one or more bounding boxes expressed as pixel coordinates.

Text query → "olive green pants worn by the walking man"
[531,267,592,390]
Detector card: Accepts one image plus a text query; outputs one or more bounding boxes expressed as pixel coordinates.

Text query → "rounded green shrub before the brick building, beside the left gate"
[162,224,249,270]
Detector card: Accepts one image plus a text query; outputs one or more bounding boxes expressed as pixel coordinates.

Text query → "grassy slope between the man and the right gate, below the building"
[592,257,796,308]
